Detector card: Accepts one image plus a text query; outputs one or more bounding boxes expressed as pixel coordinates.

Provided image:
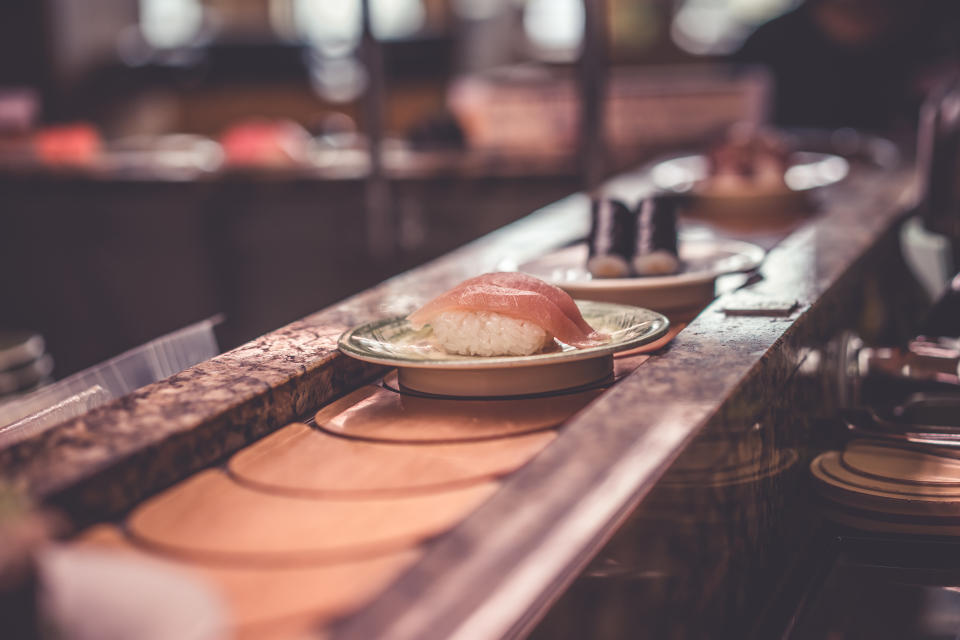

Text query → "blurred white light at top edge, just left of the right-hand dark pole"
[523,0,584,60]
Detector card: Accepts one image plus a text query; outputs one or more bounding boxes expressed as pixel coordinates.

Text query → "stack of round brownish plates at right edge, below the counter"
[810,439,960,536]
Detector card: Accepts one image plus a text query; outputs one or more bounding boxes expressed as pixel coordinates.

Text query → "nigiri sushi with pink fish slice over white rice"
[407,273,604,356]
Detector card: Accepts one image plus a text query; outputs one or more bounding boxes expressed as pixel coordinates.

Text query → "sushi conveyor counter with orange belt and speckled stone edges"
[0,156,918,640]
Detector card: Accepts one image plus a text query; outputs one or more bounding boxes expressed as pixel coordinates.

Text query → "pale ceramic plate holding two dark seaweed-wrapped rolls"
[520,235,766,312]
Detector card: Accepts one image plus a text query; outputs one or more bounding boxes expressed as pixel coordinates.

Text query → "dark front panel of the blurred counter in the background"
[0,152,576,378]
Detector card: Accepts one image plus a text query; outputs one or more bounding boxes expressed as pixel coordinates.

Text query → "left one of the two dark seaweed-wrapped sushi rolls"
[587,198,636,278]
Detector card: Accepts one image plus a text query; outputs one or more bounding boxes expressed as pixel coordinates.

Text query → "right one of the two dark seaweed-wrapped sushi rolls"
[632,196,680,276]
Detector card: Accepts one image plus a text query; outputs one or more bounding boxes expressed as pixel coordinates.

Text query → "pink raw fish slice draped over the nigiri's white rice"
[408,283,603,347]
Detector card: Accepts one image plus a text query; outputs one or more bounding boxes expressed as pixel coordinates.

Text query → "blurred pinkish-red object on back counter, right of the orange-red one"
[220,120,313,167]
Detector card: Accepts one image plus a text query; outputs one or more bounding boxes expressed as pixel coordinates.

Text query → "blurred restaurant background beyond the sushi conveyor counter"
[0,0,960,384]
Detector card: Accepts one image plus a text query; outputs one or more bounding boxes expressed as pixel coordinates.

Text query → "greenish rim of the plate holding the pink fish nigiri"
[337,300,670,370]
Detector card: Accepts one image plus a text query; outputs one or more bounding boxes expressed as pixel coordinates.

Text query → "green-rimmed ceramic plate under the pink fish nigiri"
[339,301,670,397]
